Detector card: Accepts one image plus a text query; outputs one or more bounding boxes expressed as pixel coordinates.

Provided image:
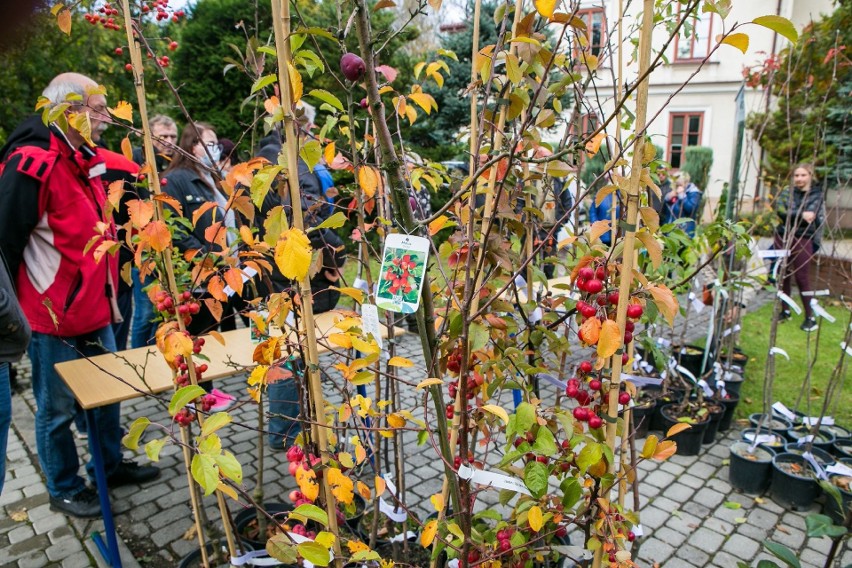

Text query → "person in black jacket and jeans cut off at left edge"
[0,248,31,493]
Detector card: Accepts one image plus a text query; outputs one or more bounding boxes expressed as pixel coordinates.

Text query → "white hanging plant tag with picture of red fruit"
[376,233,429,314]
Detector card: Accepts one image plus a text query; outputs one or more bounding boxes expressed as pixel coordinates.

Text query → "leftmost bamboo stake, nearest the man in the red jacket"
[116,0,237,566]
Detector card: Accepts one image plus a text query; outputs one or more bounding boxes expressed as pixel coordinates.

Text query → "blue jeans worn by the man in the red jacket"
[28,326,122,497]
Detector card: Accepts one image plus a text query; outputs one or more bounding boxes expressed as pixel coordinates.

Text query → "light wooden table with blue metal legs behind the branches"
[55,311,405,568]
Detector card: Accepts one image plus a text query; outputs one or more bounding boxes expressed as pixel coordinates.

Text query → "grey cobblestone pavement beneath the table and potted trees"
[0,290,852,568]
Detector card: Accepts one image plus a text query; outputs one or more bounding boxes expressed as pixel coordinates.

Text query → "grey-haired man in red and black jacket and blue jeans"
[0,73,159,517]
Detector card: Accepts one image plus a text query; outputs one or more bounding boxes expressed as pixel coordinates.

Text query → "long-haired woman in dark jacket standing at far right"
[775,164,825,331]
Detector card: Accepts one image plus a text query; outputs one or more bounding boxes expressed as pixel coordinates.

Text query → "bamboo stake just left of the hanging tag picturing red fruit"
[272,0,342,566]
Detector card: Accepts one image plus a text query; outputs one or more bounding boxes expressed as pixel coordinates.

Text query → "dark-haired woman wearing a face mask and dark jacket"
[163,122,237,411]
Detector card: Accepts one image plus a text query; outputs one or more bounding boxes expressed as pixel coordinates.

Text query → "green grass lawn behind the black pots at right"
[737,303,852,428]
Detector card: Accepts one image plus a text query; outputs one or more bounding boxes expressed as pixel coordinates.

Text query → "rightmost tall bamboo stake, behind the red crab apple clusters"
[593,0,654,568]
